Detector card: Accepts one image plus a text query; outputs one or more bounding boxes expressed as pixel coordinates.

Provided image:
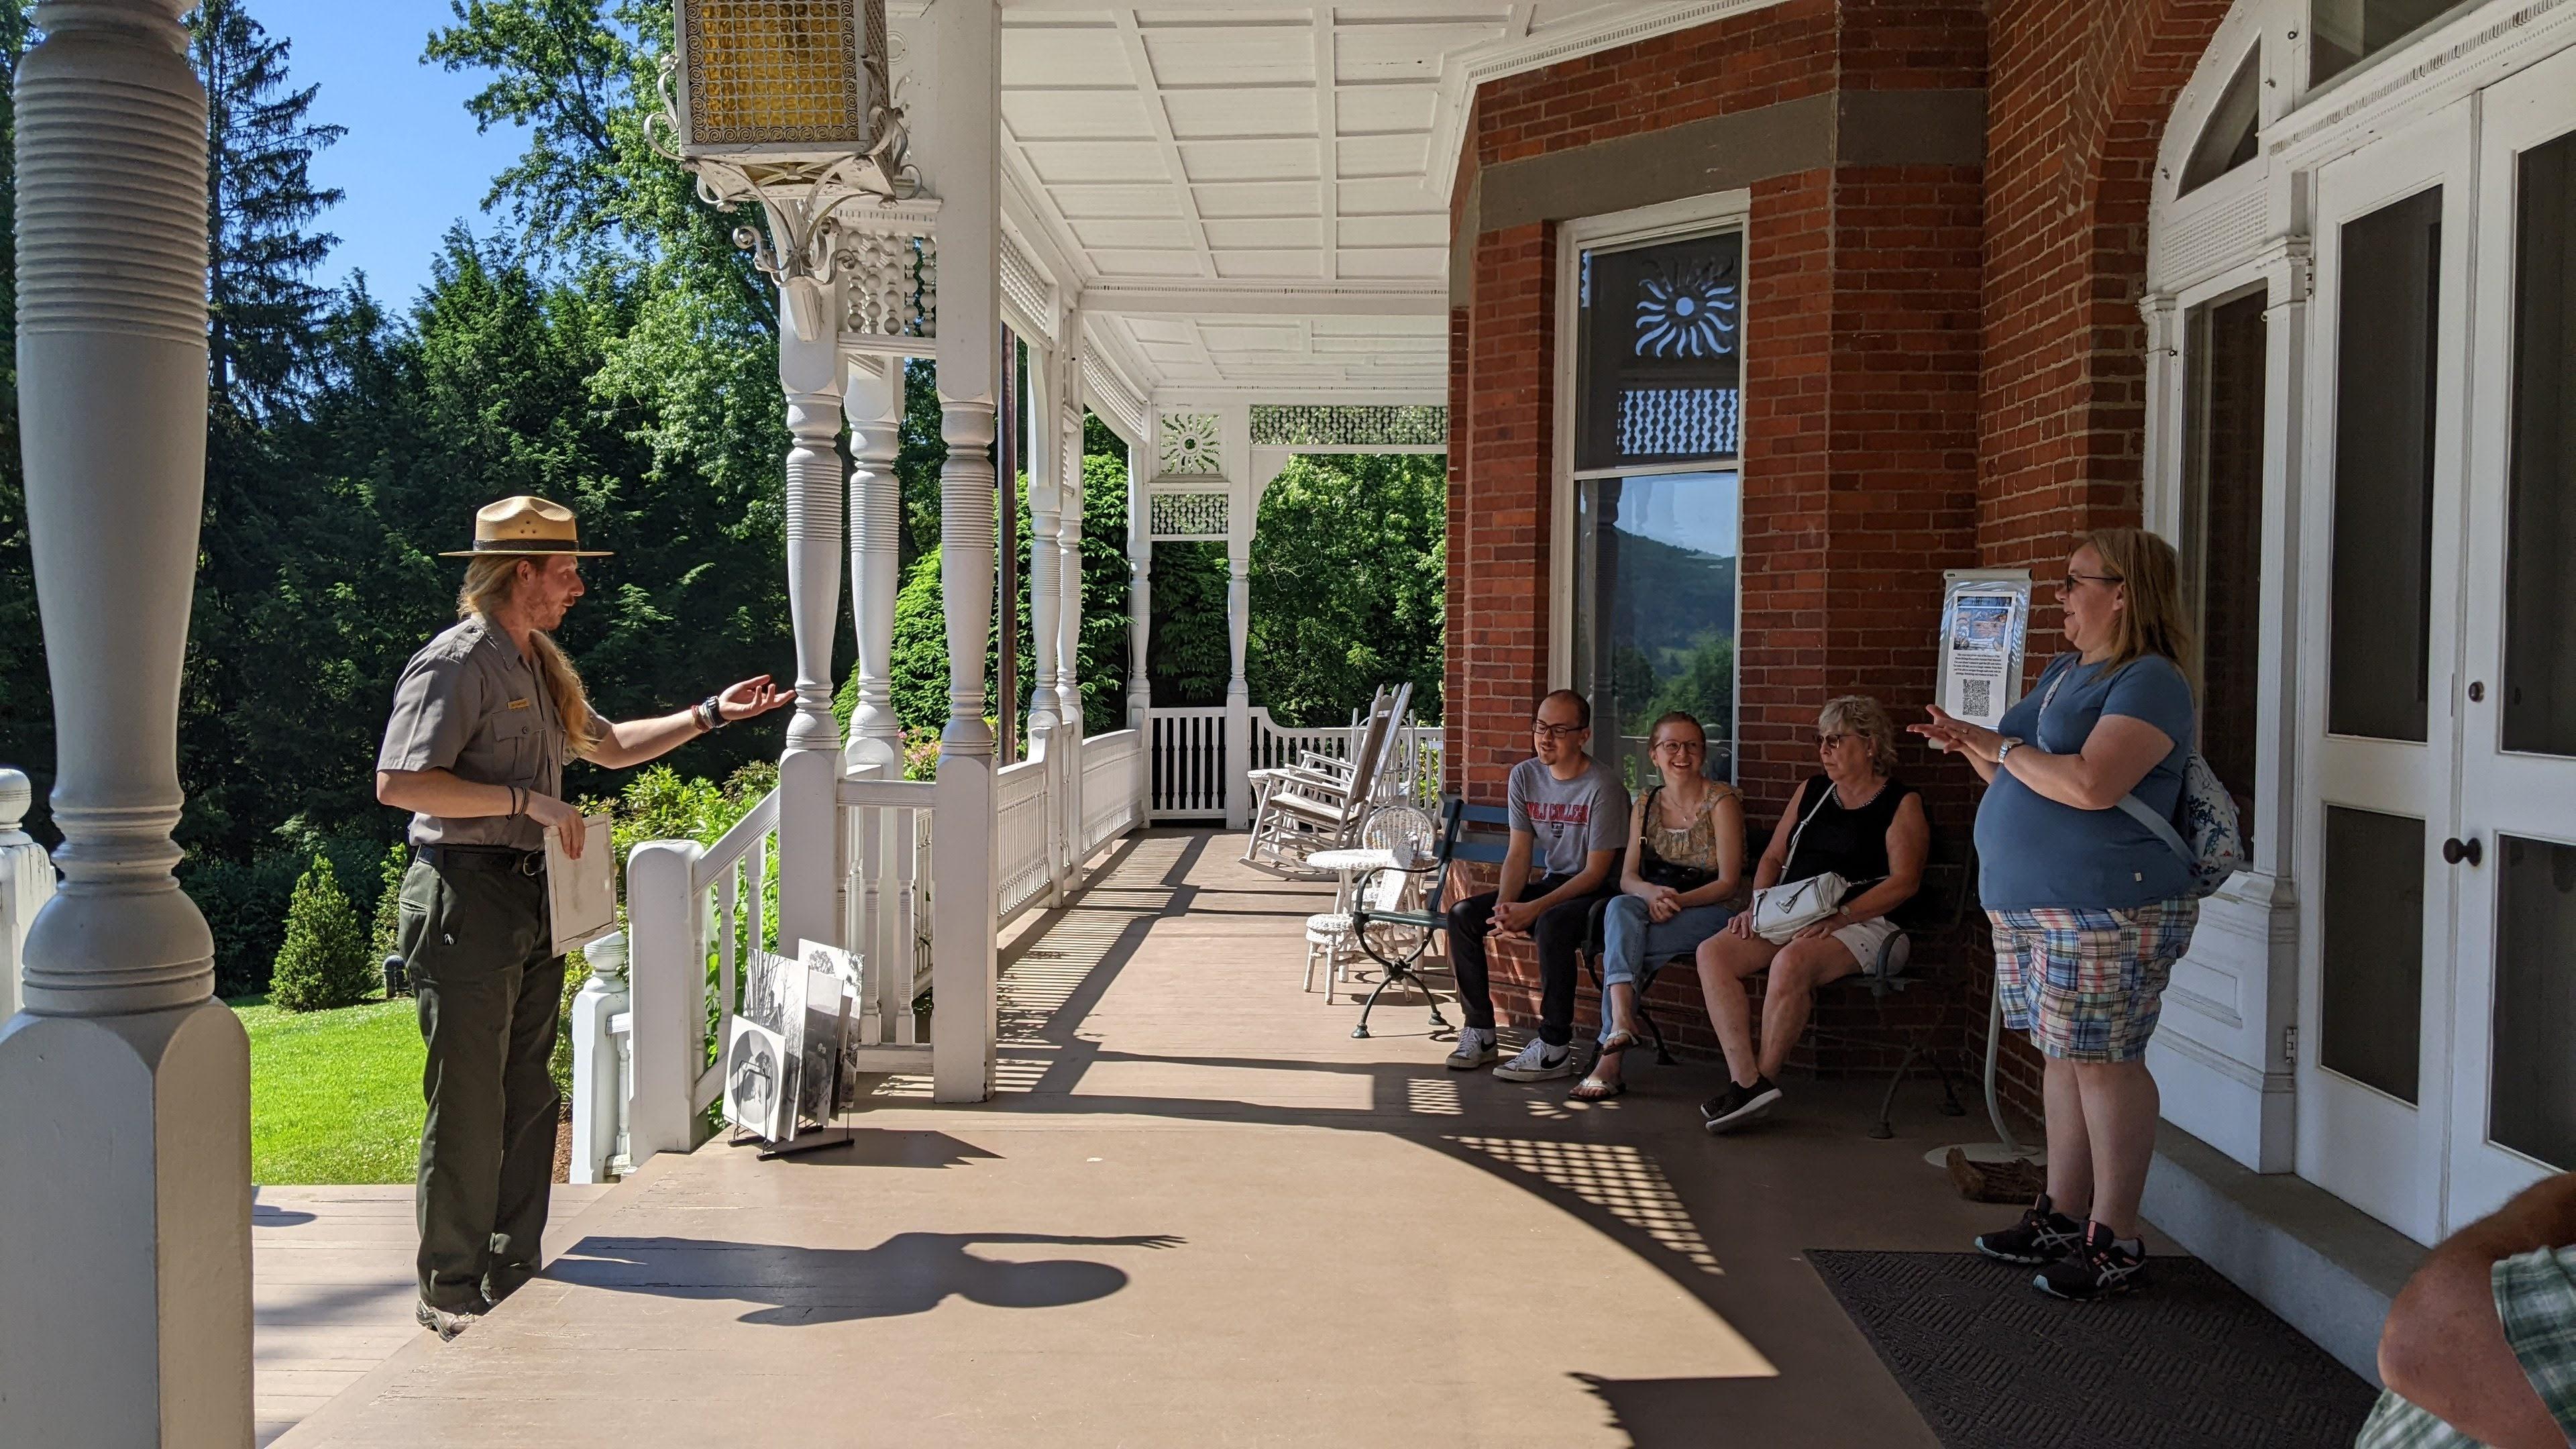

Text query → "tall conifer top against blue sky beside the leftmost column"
[188,0,347,418]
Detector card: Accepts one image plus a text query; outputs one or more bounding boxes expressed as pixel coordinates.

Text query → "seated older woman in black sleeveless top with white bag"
[1700,694,1932,1132]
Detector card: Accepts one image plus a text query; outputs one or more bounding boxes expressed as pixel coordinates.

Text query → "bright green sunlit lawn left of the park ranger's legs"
[232,996,423,1183]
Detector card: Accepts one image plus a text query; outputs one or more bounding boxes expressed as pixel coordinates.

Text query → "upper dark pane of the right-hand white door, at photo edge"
[2504,134,2576,755]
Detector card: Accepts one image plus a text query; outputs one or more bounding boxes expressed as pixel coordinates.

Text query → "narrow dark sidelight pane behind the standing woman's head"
[2182,291,2264,846]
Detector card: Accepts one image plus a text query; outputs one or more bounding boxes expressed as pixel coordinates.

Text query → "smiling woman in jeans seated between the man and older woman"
[1571,709,1744,1101]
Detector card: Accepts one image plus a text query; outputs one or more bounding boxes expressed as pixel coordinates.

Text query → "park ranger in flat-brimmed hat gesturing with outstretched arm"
[376,498,791,1338]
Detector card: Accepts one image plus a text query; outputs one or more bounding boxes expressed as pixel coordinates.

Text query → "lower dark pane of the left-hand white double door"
[2316,804,2424,1104]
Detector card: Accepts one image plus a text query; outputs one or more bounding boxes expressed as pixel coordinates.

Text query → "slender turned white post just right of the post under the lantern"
[840,358,904,779]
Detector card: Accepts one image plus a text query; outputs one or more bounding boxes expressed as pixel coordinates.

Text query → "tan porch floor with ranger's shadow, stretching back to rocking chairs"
[263,833,2029,1449]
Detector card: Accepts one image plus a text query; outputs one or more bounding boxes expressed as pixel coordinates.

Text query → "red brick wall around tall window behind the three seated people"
[1448,0,1986,1067]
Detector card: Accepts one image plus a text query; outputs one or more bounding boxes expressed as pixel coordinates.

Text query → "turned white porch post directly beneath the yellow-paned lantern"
[778,291,845,949]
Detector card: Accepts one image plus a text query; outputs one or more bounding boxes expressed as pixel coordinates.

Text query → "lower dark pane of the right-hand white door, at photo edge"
[2486,835,2576,1168]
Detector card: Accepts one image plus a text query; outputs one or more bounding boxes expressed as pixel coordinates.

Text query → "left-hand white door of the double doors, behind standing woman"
[2298,101,2475,1243]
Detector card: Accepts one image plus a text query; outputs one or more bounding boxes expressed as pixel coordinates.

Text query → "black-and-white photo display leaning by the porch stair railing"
[724,941,858,1161]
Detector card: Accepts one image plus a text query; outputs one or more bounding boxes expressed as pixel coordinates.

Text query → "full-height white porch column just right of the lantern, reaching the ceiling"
[920,0,1002,1101]
